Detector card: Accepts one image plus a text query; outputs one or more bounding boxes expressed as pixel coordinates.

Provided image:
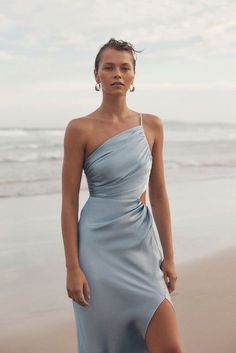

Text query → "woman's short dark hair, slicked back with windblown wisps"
[94,38,142,72]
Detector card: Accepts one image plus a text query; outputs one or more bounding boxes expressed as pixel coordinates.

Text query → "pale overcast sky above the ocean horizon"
[0,0,236,128]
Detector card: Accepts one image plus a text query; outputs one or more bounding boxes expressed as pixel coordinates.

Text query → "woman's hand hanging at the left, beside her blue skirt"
[66,268,90,306]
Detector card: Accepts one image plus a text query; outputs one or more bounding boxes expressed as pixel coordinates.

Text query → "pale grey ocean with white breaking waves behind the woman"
[0,121,236,198]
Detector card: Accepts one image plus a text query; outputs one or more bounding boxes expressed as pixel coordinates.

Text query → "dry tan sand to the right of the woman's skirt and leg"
[172,247,236,353]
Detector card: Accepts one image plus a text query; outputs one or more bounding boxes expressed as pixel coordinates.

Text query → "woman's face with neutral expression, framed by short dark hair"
[94,48,135,95]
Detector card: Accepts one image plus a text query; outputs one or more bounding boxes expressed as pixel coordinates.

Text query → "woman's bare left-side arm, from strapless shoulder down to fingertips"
[61,119,90,306]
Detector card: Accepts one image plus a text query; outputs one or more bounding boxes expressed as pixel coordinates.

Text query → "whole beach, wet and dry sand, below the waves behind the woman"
[0,176,236,353]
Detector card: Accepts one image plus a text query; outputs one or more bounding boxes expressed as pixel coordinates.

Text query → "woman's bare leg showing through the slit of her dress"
[145,299,183,353]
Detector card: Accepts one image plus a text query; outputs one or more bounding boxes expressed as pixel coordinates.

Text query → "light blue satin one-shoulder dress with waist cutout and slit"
[72,114,173,353]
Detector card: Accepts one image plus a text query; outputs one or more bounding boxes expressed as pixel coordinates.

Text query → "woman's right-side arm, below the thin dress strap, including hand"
[149,116,177,290]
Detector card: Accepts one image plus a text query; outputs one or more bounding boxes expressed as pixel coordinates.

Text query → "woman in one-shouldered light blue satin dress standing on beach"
[62,38,182,353]
